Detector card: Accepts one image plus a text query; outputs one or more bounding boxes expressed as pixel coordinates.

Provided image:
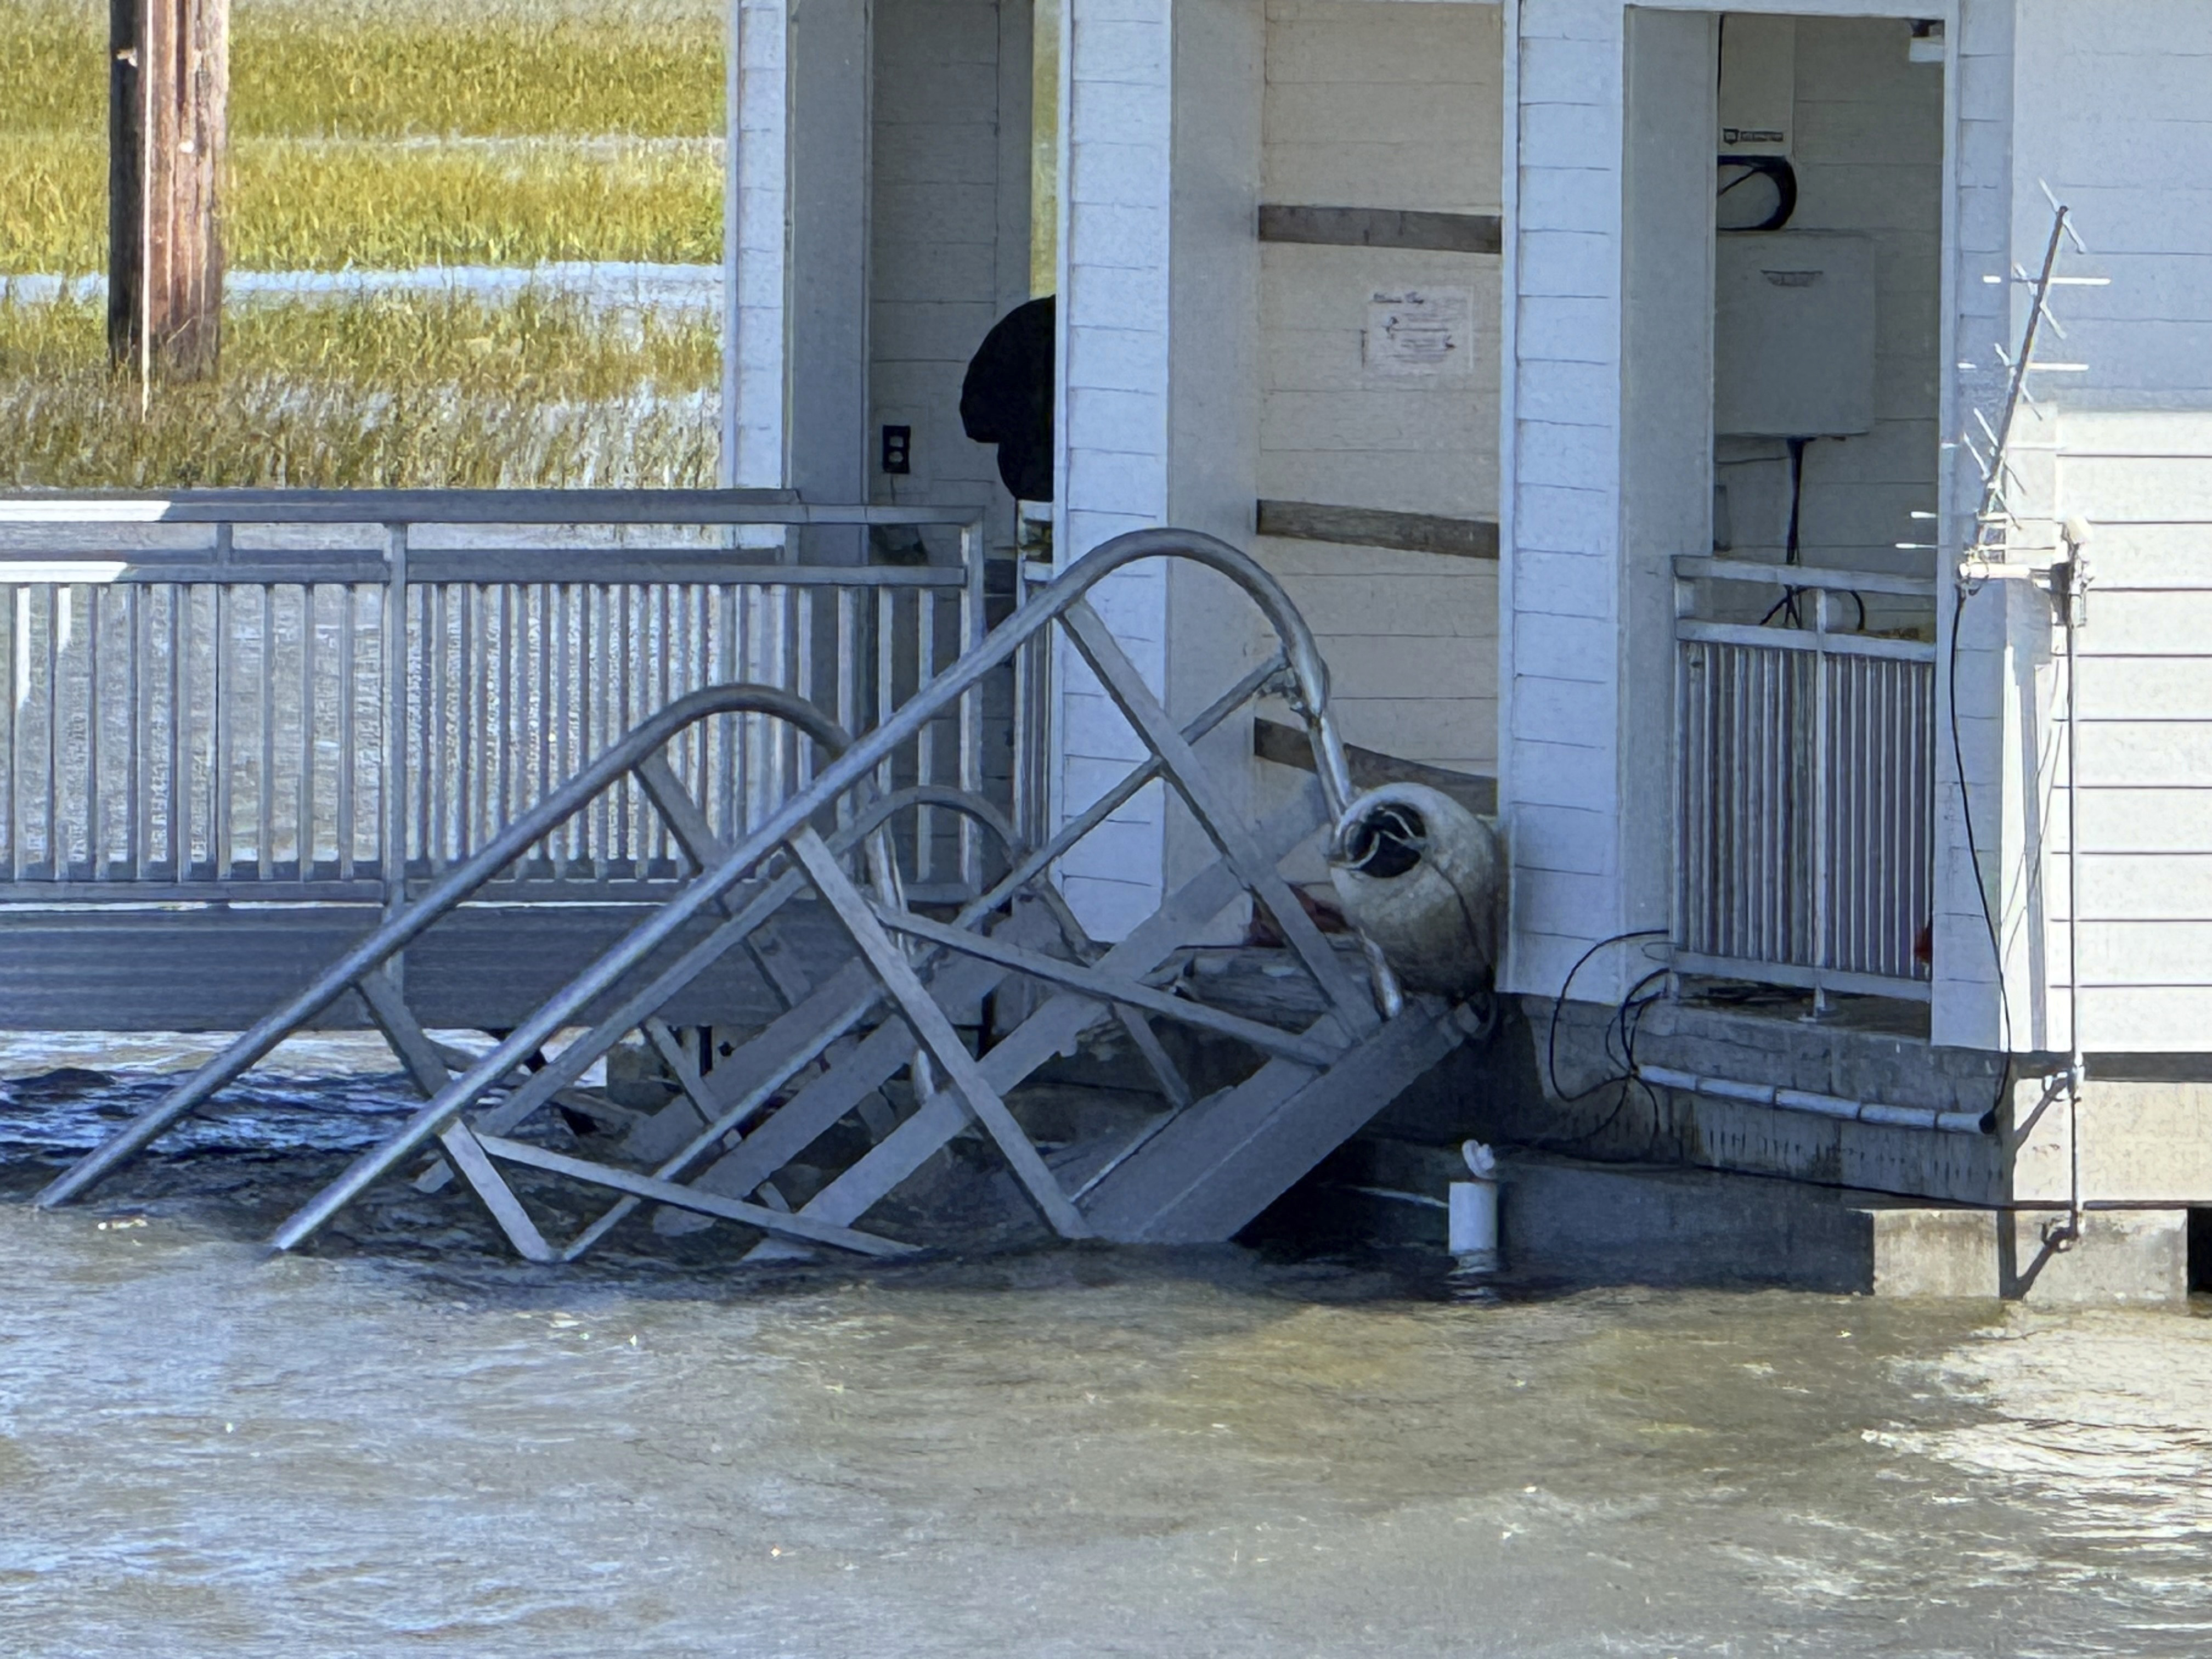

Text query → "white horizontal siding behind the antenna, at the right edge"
[1960,0,2212,1053]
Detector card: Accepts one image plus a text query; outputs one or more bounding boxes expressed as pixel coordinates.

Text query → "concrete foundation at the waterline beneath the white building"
[1070,969,2212,1303]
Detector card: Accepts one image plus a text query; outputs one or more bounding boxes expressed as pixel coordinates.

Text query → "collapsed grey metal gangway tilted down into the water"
[38,531,1480,1261]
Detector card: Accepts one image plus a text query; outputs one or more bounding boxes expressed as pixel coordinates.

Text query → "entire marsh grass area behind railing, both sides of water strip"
[0,0,725,489]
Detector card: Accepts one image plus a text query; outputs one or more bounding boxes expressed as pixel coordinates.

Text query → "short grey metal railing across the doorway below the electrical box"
[1672,557,1936,1009]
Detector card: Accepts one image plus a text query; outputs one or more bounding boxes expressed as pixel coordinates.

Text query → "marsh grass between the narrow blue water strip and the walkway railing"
[0,290,719,489]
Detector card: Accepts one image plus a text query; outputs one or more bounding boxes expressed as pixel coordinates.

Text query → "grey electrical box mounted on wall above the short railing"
[1712,230,1876,438]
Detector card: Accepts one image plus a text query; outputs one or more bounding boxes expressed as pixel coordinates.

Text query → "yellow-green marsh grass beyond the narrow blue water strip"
[0,0,723,274]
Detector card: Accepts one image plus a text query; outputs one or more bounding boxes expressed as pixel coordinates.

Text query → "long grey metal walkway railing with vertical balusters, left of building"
[0,491,1013,905]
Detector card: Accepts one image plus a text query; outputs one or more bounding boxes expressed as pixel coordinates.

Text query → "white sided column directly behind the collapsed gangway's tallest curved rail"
[1055,0,1265,943]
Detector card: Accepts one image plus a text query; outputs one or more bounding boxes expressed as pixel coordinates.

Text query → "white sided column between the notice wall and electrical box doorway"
[1498,0,1637,1000]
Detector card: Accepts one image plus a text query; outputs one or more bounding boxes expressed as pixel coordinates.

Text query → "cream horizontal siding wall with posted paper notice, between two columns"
[1259,0,1502,787]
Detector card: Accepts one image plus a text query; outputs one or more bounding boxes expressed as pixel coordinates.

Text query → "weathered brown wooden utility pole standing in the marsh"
[109,0,230,387]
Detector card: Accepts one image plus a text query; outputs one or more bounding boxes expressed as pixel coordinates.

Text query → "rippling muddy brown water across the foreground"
[0,1055,2212,1659]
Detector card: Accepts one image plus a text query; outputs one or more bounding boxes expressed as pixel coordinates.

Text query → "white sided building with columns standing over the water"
[732,0,2212,1300]
